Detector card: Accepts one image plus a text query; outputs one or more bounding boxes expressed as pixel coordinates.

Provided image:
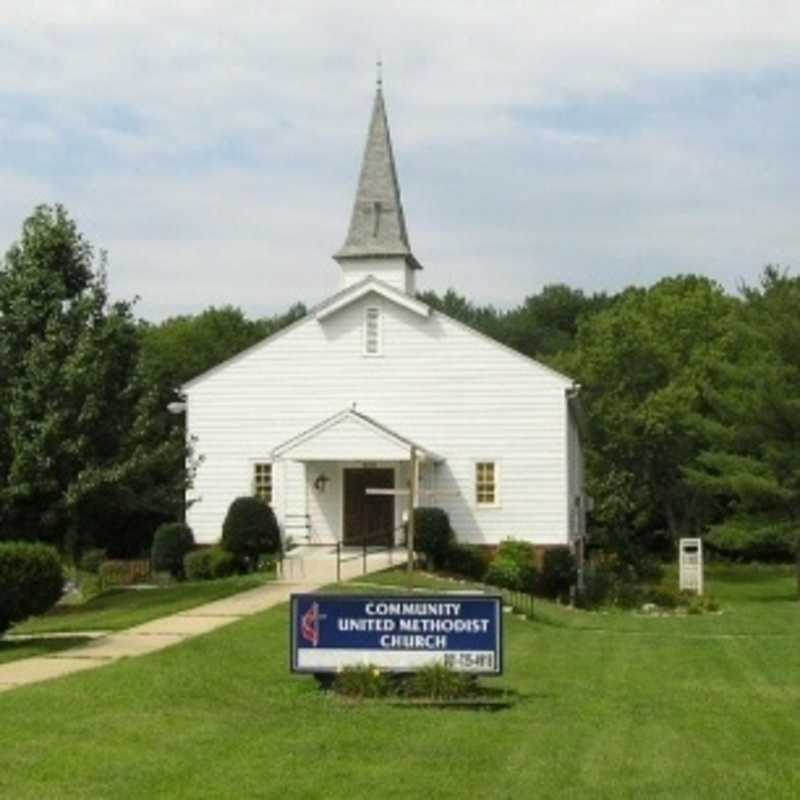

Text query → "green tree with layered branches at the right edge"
[685,267,800,592]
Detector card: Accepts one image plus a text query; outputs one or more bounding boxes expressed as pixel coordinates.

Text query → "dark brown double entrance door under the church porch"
[342,469,394,546]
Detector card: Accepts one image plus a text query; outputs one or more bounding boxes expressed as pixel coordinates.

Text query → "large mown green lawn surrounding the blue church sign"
[0,569,800,800]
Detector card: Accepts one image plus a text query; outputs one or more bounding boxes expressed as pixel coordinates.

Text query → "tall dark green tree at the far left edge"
[0,206,138,544]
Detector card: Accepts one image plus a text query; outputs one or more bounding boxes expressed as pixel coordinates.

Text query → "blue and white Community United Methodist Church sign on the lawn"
[291,594,503,675]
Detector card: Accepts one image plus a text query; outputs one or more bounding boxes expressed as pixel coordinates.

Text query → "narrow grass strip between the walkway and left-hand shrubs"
[14,573,270,633]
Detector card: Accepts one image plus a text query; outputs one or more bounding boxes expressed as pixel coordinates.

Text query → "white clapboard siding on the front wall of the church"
[186,293,576,544]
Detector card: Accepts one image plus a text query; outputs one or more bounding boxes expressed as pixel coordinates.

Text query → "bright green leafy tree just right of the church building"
[563,275,736,555]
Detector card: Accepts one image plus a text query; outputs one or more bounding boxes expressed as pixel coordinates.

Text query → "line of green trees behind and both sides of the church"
[0,206,800,560]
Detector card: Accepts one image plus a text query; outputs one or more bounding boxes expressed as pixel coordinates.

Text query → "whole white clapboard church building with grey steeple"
[182,83,586,549]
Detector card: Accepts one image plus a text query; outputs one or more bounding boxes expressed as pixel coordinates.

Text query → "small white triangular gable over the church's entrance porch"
[271,407,442,461]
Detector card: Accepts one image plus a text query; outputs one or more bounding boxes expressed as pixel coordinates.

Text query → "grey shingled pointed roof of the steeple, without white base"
[334,86,422,269]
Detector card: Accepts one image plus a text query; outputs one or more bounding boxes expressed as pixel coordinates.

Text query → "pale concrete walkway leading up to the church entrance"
[0,552,402,692]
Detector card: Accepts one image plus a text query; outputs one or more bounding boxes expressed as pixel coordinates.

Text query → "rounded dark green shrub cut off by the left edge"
[0,542,64,633]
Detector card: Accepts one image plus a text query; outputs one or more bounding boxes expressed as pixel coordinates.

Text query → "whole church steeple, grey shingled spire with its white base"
[334,79,422,294]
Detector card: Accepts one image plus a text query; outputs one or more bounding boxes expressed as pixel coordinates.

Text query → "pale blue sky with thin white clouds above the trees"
[0,0,800,320]
